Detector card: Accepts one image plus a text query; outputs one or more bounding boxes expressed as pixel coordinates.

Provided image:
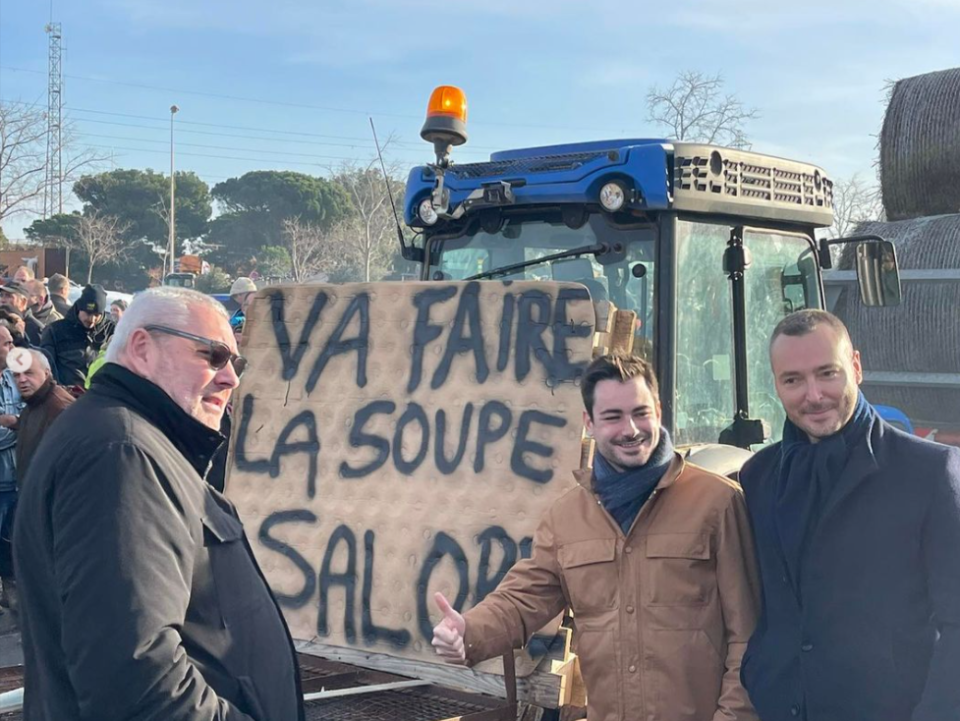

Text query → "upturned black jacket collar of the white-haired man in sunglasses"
[90,363,225,478]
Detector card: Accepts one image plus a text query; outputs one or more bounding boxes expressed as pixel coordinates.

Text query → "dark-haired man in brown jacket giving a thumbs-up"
[433,355,759,721]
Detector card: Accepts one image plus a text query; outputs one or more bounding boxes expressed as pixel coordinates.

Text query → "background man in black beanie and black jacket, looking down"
[40,285,114,387]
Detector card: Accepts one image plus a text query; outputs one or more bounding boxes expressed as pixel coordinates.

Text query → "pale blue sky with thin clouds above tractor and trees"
[0,0,960,238]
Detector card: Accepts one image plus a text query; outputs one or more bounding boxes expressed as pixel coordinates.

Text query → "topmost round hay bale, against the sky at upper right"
[880,68,960,220]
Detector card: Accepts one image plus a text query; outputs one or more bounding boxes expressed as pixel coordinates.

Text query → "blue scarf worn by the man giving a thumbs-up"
[593,428,673,533]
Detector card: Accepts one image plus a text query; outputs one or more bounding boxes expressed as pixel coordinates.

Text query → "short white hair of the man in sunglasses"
[105,286,230,363]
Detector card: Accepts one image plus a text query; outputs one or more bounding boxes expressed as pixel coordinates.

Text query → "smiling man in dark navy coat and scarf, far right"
[740,310,960,721]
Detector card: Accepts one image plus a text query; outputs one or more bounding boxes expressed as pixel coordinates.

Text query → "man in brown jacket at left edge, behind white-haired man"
[7,348,74,486]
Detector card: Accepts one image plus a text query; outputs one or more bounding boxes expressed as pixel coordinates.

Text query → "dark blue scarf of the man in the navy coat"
[774,393,877,589]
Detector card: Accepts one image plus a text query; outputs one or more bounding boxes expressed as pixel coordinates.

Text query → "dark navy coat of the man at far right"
[740,420,960,721]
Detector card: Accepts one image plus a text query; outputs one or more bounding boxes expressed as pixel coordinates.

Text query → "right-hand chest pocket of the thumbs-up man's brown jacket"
[643,533,716,606]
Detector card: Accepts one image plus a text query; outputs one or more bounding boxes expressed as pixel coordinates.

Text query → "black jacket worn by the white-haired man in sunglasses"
[14,363,303,721]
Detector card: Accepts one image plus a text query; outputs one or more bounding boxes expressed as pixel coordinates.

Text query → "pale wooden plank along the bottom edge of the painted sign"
[296,641,560,708]
